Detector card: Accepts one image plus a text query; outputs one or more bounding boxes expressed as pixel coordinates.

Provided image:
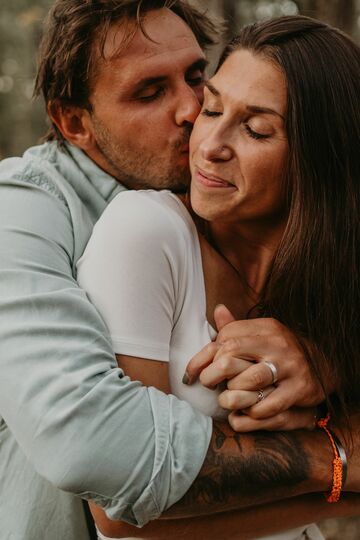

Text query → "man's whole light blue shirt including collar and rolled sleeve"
[0,143,211,540]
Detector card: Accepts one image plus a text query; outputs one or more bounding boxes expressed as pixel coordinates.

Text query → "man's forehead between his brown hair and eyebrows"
[90,9,206,92]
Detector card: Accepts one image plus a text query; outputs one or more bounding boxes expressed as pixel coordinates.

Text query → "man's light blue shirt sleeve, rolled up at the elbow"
[0,151,211,526]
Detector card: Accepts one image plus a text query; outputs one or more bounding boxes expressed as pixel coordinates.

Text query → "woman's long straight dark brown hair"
[221,16,360,413]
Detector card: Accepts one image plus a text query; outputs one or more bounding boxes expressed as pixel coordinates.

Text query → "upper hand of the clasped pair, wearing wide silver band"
[184,316,324,419]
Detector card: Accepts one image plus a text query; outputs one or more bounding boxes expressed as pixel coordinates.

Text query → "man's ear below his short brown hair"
[47,100,96,152]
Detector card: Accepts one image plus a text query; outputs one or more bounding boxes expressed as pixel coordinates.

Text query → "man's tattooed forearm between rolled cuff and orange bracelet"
[164,423,334,518]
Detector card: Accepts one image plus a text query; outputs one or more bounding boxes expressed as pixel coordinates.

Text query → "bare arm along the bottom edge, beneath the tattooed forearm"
[95,493,360,540]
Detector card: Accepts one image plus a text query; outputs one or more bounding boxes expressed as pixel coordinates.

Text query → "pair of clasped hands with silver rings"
[187,306,325,431]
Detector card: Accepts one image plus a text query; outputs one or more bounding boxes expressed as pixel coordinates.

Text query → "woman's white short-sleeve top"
[77,190,227,418]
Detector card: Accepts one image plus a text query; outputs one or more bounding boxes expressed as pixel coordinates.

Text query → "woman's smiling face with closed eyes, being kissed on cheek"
[190,50,288,223]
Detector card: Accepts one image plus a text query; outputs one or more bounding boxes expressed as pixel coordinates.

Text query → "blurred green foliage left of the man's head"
[0,0,52,158]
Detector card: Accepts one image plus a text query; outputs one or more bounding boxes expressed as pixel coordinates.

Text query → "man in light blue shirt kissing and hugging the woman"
[0,0,360,540]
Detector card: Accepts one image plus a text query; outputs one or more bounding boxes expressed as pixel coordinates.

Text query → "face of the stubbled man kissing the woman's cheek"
[88,9,206,190]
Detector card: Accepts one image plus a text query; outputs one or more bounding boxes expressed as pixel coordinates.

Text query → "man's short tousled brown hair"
[34,0,217,140]
